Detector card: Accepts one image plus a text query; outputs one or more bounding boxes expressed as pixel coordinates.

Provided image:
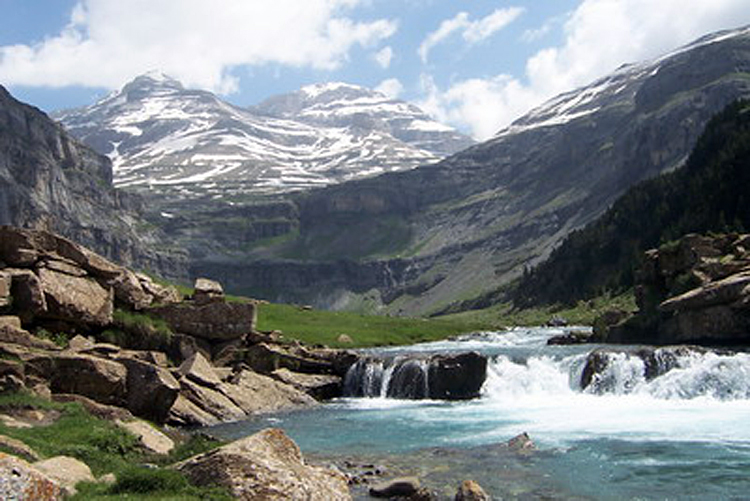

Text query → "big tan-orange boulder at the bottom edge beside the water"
[178,428,351,501]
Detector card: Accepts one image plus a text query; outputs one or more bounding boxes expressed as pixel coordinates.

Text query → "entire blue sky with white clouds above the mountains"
[0,0,750,139]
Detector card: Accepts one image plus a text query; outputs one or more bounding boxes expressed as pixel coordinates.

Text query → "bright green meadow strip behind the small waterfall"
[258,304,489,348]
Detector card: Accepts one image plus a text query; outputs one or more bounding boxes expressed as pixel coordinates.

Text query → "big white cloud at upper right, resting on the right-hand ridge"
[421,0,750,139]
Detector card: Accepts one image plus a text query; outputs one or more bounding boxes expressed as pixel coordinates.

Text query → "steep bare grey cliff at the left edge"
[0,86,185,277]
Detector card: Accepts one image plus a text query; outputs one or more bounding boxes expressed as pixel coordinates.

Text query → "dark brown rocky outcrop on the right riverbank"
[598,234,750,344]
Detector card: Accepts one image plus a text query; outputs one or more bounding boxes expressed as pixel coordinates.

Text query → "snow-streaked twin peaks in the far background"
[58,73,473,199]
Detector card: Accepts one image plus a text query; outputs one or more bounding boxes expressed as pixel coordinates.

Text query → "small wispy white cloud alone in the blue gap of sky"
[417,7,524,63]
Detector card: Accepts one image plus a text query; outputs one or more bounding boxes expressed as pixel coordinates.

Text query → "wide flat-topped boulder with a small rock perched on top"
[149,302,257,341]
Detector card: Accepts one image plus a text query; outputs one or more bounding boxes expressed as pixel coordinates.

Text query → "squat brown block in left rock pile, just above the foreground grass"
[50,353,128,406]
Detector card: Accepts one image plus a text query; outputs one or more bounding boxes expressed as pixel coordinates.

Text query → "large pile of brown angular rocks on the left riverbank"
[0,226,356,426]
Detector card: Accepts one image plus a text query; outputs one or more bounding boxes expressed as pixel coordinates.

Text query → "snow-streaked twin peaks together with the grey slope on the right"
[14,24,750,315]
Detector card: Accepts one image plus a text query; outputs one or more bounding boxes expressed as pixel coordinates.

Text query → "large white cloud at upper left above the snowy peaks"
[0,0,397,93]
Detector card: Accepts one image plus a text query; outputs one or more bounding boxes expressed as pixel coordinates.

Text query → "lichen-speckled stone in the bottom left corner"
[0,452,63,501]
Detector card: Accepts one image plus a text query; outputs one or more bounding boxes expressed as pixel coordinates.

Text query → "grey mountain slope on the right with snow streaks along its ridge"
[187,28,750,314]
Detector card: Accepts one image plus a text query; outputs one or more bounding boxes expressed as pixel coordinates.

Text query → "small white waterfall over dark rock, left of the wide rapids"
[344,357,430,400]
